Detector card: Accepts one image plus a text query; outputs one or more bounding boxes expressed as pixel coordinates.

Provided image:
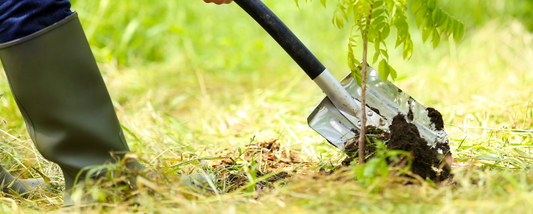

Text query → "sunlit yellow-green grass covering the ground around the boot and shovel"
[0,0,533,213]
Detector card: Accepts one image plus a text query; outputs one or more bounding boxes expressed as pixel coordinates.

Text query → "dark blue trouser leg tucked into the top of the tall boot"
[0,0,72,43]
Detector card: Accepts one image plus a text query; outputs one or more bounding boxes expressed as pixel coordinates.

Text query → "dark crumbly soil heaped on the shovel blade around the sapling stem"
[342,108,453,182]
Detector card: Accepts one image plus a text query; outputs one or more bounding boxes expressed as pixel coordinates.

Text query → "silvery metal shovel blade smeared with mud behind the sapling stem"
[307,66,448,150]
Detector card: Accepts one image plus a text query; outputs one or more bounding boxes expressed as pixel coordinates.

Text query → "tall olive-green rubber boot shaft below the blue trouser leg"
[0,13,143,205]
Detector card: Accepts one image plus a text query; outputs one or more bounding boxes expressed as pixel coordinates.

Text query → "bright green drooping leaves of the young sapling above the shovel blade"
[320,0,465,82]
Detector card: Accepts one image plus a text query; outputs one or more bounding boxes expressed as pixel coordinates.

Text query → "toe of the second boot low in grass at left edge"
[0,166,50,196]
